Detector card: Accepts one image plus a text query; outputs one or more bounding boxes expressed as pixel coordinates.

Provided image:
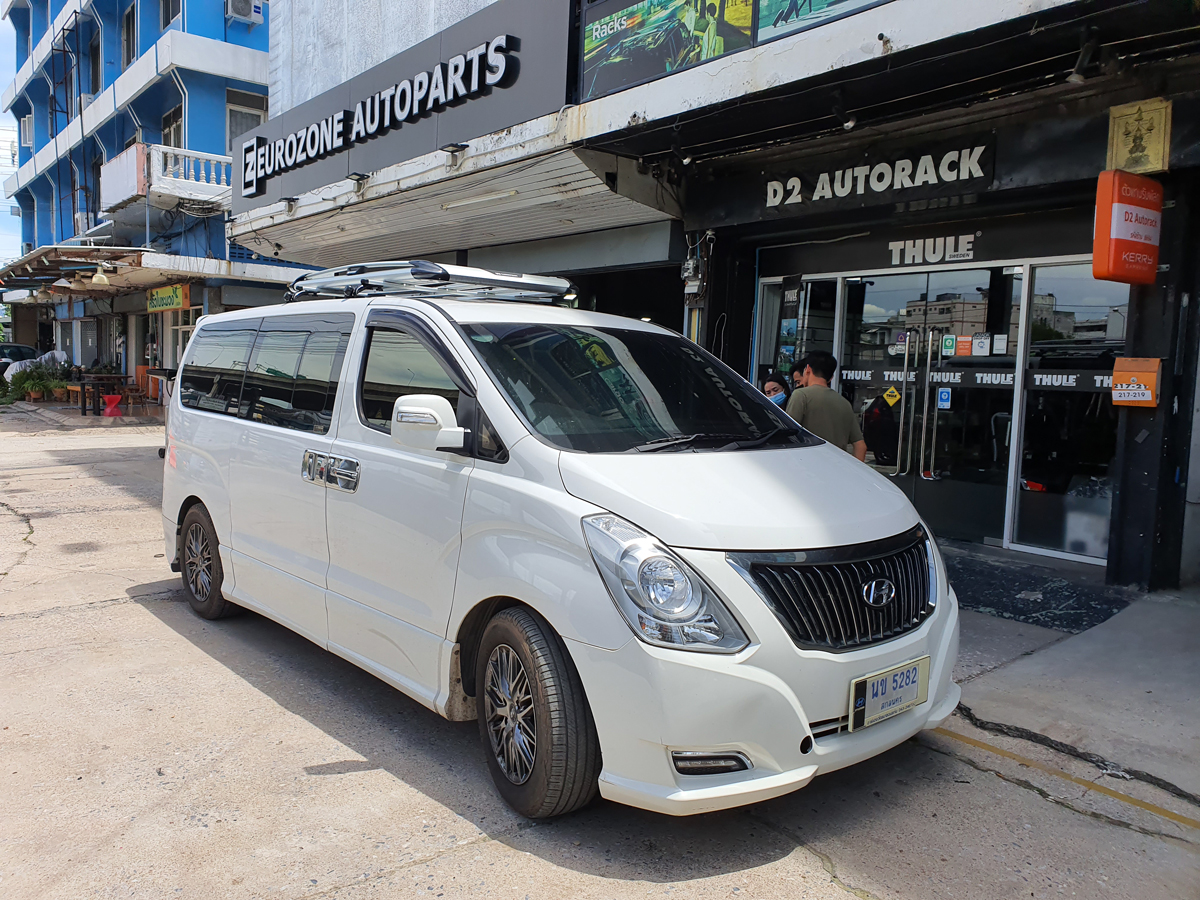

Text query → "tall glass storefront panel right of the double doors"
[1014,264,1129,558]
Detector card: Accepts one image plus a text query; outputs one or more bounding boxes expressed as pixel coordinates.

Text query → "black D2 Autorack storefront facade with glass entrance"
[685,81,1200,588]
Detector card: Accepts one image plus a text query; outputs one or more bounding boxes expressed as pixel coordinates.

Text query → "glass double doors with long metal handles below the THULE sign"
[841,268,1021,544]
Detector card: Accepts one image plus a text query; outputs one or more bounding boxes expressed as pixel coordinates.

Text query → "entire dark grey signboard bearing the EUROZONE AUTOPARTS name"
[233,0,571,215]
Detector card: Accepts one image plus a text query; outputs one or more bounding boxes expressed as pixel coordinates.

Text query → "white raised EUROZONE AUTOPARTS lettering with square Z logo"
[241,35,520,197]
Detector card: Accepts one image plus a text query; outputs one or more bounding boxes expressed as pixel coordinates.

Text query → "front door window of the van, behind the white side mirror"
[361,328,458,434]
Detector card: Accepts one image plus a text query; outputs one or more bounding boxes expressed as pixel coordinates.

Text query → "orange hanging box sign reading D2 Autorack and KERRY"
[1092,169,1163,284]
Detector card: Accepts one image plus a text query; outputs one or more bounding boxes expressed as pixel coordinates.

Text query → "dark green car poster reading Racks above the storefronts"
[580,0,748,100]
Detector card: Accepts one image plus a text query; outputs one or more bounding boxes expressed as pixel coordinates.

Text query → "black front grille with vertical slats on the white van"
[728,526,934,650]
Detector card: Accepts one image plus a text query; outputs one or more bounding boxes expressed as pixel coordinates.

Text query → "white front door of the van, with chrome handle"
[326,310,472,707]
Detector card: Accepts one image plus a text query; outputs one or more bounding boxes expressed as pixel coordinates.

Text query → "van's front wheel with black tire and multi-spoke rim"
[475,607,600,818]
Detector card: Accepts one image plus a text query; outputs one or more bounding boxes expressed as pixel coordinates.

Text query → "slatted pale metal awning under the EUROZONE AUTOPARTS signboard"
[230,150,673,268]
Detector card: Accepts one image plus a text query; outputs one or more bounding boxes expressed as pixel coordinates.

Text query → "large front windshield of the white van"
[462,323,821,452]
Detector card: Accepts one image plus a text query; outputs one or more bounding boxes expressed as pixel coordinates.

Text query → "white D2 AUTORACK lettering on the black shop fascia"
[760,134,996,216]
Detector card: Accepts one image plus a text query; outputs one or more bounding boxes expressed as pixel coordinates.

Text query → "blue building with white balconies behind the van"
[0,0,299,376]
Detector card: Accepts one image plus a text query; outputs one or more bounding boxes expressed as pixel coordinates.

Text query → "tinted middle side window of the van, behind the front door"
[240,313,354,434]
